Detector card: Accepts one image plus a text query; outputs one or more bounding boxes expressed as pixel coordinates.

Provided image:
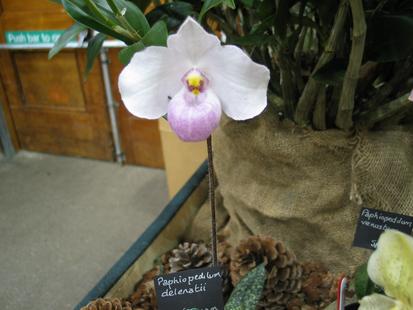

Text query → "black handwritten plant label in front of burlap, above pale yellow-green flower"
[353,208,413,250]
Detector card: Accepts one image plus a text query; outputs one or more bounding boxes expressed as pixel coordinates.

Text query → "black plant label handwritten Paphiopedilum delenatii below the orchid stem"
[154,267,224,310]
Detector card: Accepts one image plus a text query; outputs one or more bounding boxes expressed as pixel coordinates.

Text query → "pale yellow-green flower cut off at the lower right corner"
[359,230,413,310]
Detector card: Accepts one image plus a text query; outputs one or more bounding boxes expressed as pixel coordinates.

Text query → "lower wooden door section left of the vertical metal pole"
[0,50,113,160]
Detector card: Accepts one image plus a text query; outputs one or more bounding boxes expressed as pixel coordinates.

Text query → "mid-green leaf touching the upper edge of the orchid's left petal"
[119,21,168,65]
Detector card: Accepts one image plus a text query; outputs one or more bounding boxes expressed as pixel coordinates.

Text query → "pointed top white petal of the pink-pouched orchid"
[168,17,220,68]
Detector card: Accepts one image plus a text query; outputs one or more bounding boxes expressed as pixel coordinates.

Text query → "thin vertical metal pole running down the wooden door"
[100,48,124,164]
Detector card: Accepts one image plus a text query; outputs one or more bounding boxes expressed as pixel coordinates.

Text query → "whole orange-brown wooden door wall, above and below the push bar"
[0,0,164,168]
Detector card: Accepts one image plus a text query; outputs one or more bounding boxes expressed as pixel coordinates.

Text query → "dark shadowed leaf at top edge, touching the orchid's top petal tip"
[146,1,194,30]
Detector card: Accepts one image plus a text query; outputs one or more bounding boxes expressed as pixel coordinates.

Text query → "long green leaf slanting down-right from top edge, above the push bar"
[62,0,134,44]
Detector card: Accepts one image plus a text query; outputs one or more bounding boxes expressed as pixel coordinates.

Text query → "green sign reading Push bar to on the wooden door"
[5,30,63,45]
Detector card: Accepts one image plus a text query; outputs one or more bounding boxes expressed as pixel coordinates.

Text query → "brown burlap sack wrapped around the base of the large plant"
[187,108,413,271]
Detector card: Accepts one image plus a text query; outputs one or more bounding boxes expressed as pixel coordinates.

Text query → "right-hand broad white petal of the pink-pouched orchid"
[199,45,270,120]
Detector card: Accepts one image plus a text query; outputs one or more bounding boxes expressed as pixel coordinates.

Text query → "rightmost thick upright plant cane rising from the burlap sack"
[336,0,367,130]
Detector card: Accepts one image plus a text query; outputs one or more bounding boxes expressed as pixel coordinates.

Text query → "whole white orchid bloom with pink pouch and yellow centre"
[119,17,270,141]
